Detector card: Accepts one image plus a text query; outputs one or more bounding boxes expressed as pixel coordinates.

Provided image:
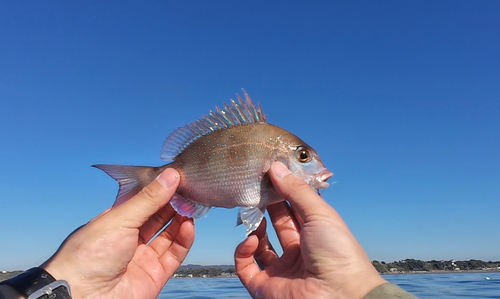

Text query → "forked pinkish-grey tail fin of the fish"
[92,164,161,207]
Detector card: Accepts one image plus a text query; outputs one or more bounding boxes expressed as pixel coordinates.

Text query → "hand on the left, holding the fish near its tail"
[41,169,194,298]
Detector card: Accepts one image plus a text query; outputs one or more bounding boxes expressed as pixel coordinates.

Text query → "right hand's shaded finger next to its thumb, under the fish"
[267,201,300,251]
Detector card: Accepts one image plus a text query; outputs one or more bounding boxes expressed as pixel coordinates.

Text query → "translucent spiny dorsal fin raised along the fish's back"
[161,90,266,161]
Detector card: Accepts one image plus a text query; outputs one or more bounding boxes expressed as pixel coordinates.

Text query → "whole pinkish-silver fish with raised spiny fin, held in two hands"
[92,90,333,236]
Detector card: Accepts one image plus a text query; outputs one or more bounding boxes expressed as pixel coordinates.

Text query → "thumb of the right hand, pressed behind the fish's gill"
[269,162,345,225]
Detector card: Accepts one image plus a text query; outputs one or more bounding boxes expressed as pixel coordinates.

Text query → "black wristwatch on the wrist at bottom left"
[0,268,71,299]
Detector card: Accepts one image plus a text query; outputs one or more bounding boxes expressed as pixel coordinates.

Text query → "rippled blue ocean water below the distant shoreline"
[158,272,500,299]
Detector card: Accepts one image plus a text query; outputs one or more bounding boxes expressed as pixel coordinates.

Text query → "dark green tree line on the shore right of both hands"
[372,259,500,273]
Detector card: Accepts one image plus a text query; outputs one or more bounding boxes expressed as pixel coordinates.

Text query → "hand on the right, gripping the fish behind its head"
[235,162,386,298]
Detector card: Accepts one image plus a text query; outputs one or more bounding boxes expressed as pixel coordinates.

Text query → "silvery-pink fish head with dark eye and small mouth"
[286,144,333,190]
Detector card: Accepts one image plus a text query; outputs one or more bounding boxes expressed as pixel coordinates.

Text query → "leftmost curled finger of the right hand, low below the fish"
[234,235,265,297]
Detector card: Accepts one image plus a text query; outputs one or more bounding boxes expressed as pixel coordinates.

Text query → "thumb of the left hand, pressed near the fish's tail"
[108,168,179,228]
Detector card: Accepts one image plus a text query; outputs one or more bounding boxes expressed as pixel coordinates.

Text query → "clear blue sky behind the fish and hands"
[0,0,500,270]
